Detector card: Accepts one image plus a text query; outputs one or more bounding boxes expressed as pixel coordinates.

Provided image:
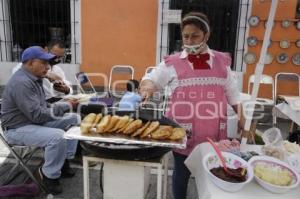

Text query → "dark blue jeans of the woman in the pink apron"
[172,151,191,199]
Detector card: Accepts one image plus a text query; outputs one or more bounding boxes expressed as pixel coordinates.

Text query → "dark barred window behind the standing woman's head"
[169,0,239,64]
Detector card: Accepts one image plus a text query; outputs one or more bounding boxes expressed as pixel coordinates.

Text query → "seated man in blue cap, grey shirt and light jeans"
[0,46,78,194]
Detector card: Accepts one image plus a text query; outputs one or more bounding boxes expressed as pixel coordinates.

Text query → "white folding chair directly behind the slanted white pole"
[248,74,275,124]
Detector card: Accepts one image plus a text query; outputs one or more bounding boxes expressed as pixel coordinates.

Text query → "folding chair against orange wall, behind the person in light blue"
[108,65,134,97]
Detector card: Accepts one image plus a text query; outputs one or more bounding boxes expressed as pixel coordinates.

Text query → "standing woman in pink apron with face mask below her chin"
[140,12,239,199]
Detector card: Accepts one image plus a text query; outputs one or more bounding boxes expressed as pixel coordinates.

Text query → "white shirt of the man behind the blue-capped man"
[12,63,73,99]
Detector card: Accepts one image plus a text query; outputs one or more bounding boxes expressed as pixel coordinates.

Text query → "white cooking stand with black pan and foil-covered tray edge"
[65,110,187,199]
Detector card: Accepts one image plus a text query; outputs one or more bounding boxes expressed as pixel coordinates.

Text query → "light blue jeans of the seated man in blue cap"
[5,114,80,179]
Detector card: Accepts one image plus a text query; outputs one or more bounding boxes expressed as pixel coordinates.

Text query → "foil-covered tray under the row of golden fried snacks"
[64,111,187,149]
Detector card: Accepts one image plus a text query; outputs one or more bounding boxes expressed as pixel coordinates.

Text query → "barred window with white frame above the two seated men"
[0,0,80,63]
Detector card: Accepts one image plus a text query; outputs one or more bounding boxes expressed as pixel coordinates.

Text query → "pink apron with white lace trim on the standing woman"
[165,51,231,155]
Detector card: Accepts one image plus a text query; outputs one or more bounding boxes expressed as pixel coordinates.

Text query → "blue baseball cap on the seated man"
[22,46,56,63]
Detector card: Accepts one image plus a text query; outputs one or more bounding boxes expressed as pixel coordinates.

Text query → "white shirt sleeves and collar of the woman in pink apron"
[142,48,240,105]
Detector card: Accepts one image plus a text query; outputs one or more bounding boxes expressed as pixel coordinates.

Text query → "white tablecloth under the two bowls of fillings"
[185,142,300,199]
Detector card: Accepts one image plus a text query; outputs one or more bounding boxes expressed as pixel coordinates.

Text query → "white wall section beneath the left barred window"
[0,62,80,85]
